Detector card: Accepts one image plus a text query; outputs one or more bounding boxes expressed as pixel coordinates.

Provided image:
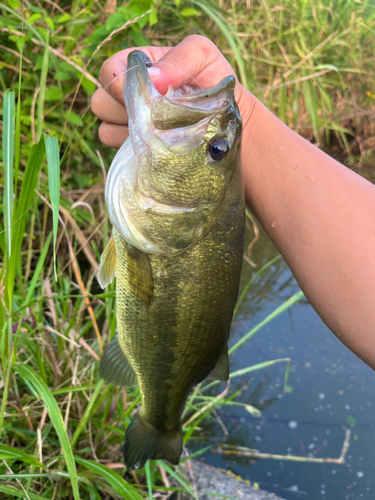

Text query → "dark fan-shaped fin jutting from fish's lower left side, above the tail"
[99,335,138,387]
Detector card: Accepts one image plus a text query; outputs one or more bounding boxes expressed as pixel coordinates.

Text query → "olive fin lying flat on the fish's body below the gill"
[127,244,154,306]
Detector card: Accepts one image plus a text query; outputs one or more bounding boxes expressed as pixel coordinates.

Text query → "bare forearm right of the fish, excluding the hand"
[241,87,375,368]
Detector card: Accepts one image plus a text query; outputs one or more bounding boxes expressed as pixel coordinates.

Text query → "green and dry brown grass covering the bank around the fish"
[0,0,375,500]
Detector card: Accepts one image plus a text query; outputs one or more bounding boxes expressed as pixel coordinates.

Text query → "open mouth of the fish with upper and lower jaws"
[128,50,236,130]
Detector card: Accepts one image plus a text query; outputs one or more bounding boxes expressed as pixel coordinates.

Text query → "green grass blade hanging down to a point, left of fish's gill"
[44,134,60,281]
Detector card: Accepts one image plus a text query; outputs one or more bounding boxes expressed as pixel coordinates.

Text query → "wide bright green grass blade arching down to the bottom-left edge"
[17,365,80,500]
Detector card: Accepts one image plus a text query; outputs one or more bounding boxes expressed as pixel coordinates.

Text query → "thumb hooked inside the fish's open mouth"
[148,35,235,94]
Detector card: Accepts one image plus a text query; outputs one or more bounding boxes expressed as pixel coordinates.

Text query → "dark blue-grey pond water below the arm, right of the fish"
[190,225,375,500]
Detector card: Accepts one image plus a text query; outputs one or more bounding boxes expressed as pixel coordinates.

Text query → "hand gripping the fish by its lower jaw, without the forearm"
[91,35,251,148]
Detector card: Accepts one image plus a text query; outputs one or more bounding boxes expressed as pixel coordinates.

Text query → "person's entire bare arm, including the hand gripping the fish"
[93,36,375,369]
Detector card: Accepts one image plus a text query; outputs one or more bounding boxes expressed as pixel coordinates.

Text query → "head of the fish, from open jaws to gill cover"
[106,50,242,255]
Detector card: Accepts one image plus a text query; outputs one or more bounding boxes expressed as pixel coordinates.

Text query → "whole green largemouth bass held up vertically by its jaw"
[98,50,245,469]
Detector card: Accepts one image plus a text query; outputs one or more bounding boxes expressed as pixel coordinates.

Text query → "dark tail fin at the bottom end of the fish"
[124,413,182,469]
